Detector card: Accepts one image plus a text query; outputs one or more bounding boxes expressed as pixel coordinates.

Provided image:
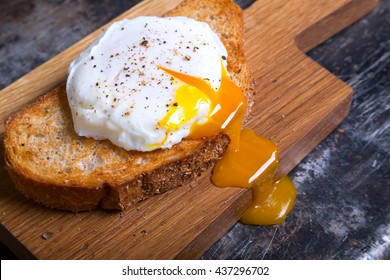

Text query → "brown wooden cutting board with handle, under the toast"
[0,0,377,259]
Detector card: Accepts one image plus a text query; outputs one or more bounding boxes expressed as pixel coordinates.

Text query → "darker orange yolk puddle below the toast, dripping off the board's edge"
[211,130,296,226]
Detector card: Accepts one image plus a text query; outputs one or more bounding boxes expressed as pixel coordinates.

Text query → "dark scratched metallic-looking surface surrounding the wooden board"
[0,0,390,259]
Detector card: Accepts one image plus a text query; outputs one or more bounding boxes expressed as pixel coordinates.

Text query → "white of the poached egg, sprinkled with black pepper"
[67,17,227,151]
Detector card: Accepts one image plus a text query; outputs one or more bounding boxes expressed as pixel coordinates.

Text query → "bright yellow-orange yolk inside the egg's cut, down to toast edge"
[159,62,246,149]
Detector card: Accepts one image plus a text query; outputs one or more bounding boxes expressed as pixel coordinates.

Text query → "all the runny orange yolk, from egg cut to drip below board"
[160,64,296,225]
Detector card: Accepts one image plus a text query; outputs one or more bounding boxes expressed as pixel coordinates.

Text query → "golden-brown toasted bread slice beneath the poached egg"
[4,0,253,212]
